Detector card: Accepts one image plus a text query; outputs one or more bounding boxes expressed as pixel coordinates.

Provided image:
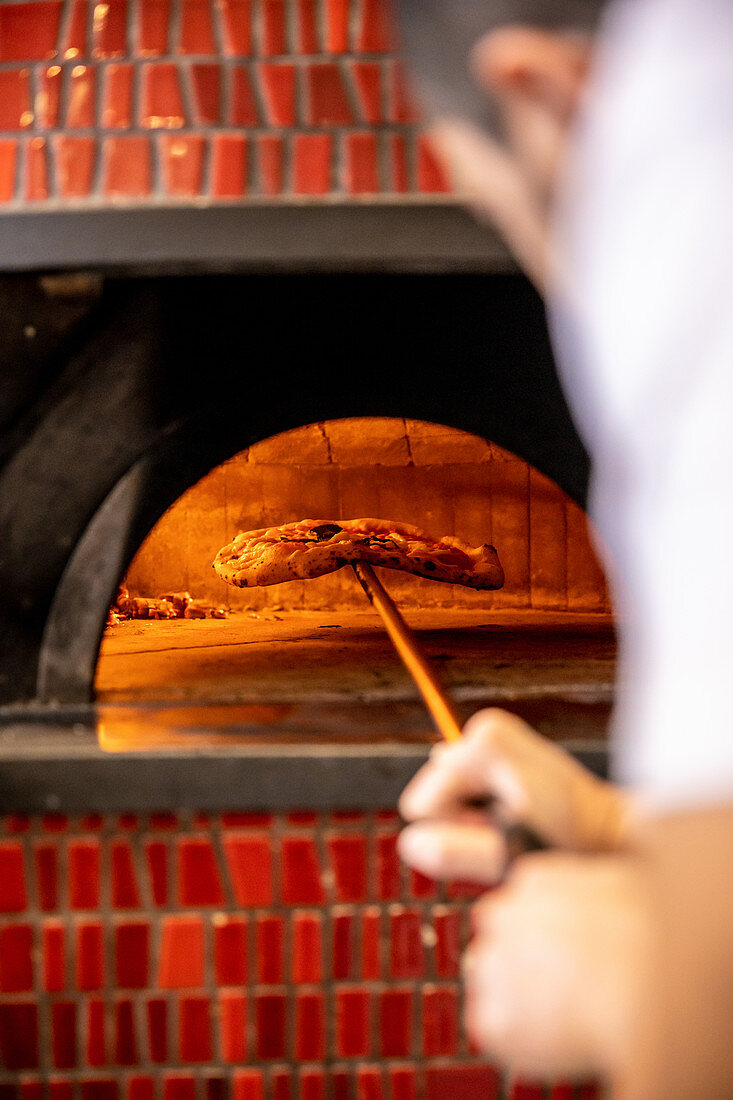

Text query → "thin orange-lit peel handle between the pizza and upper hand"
[352,561,461,741]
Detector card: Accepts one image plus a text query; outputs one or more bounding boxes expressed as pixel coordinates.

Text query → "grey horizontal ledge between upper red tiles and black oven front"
[0,200,516,274]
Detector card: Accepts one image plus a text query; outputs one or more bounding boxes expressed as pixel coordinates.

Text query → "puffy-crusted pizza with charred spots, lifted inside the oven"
[214,519,504,589]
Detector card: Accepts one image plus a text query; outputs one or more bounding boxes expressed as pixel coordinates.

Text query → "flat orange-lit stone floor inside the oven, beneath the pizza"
[96,609,615,705]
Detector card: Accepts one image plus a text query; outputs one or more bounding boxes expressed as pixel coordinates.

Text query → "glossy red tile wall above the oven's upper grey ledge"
[0,0,449,209]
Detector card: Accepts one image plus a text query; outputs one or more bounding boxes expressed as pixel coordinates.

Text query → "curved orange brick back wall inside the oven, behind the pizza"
[117,417,610,615]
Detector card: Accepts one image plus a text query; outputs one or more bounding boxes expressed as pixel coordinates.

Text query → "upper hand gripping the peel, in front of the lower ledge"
[400,710,628,884]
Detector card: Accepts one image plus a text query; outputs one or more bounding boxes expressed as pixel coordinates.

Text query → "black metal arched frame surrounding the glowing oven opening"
[0,265,588,706]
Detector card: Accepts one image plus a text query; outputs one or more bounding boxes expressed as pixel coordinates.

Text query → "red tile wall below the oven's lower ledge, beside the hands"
[0,811,600,1100]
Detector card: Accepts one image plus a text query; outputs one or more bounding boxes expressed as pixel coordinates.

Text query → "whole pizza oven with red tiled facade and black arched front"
[0,0,614,1100]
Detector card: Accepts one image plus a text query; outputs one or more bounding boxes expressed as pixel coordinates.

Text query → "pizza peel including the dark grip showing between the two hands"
[351,561,546,864]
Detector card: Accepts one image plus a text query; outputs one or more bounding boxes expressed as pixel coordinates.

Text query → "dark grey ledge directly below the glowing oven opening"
[0,712,606,814]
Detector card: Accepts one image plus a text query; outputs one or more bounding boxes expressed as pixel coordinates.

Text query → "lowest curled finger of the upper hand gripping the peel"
[397,822,506,886]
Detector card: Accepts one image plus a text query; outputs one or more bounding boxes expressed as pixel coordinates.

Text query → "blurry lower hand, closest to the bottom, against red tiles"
[464,853,648,1084]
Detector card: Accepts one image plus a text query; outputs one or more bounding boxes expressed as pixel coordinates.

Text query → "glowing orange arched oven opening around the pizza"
[95,417,614,750]
